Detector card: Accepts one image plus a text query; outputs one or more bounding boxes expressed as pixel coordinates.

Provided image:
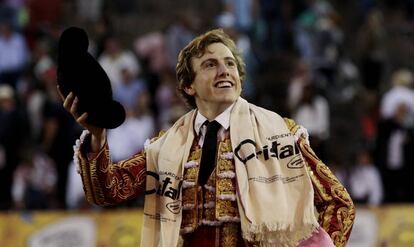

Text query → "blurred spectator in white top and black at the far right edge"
[376,69,414,202]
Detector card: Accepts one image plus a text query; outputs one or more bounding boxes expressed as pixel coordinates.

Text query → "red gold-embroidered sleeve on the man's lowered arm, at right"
[285,119,355,247]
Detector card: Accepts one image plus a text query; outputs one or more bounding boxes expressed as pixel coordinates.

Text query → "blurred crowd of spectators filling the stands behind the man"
[0,0,414,210]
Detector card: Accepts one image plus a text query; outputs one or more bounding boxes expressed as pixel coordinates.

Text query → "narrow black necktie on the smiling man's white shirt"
[198,121,221,186]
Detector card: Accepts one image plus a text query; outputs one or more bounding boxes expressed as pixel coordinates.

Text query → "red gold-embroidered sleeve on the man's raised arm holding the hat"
[75,132,146,206]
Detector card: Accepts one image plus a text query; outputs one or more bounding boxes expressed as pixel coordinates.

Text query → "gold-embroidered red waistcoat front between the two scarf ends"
[181,135,239,247]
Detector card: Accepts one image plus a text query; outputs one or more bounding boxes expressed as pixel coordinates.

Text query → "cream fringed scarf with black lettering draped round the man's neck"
[141,98,318,247]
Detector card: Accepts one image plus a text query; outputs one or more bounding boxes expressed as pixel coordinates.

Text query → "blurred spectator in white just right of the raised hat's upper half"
[98,36,140,90]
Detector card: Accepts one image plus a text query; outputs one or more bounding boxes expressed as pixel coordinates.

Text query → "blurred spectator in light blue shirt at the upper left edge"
[0,20,29,88]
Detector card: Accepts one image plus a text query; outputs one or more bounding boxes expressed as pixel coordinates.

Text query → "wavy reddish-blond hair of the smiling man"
[176,29,246,108]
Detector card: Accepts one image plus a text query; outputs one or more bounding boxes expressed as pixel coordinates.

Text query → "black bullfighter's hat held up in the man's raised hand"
[57,27,125,129]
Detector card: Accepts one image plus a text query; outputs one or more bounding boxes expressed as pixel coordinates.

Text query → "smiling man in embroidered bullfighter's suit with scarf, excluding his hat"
[64,30,355,247]
